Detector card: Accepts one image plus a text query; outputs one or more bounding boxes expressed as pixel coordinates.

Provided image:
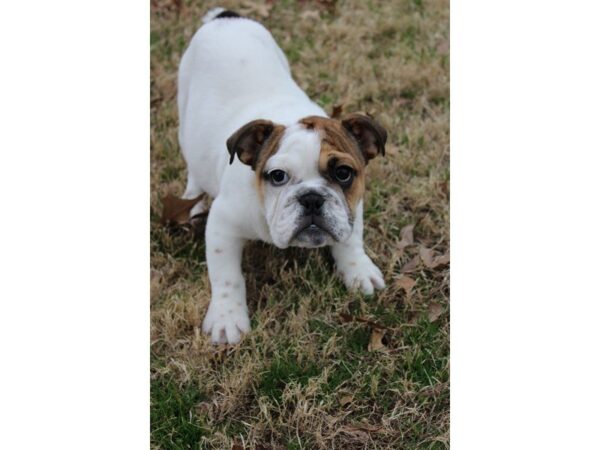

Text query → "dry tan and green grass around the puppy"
[150,0,449,449]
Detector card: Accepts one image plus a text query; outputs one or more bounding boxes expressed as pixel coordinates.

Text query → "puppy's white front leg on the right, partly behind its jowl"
[331,201,385,295]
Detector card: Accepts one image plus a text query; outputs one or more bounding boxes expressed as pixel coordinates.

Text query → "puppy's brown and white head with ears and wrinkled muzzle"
[227,114,387,248]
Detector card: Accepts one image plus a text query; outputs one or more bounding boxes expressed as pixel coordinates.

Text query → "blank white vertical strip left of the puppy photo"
[0,0,150,450]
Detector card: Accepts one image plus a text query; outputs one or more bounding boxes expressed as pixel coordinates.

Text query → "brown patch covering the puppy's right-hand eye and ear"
[300,114,386,212]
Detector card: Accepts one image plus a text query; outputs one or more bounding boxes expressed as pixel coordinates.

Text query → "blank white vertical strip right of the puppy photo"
[451,0,600,450]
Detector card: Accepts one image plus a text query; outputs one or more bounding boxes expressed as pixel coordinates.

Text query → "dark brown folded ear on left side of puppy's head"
[227,119,276,170]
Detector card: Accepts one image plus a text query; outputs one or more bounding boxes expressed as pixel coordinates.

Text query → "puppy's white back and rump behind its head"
[177,8,325,198]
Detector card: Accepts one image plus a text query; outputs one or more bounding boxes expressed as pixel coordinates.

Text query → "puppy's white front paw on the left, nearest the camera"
[202,300,250,344]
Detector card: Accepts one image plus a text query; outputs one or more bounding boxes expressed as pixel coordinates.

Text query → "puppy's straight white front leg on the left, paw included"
[202,201,250,344]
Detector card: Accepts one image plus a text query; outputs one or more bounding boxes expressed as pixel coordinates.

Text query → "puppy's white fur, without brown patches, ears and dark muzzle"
[177,11,384,343]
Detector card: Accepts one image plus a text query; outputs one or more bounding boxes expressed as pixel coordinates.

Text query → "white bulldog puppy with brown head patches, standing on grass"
[177,9,387,343]
